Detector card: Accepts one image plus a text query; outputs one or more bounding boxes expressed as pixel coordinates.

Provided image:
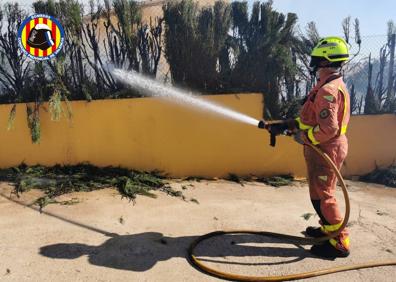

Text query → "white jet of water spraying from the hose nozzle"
[111,69,259,126]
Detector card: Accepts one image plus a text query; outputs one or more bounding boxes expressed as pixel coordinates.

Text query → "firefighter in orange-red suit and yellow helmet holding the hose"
[295,37,350,258]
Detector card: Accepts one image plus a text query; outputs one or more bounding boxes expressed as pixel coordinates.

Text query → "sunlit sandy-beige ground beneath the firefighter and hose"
[0,180,396,282]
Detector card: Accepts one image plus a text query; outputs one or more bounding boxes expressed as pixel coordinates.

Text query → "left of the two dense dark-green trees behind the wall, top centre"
[164,0,231,93]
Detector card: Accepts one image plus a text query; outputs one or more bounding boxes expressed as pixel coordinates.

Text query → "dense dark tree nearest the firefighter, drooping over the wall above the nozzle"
[230,1,297,119]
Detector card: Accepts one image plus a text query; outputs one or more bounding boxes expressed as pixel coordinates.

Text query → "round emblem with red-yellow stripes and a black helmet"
[18,14,64,60]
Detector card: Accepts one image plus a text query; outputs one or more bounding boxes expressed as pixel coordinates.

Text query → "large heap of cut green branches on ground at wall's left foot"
[0,164,183,208]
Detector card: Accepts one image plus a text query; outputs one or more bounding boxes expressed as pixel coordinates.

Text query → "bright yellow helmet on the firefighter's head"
[310,36,349,67]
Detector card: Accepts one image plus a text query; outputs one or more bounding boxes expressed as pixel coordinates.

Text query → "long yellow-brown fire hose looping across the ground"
[188,144,396,282]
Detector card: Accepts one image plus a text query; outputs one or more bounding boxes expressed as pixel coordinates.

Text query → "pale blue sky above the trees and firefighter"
[9,0,396,36]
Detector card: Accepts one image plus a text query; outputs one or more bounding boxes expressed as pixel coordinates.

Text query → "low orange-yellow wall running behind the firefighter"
[0,94,396,177]
